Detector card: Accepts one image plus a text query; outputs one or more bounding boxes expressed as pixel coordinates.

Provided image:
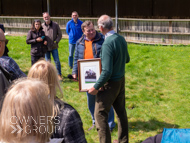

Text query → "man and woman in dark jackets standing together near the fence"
[26,12,62,80]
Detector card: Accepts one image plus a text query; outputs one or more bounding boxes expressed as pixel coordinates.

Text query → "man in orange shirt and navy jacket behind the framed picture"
[72,21,115,131]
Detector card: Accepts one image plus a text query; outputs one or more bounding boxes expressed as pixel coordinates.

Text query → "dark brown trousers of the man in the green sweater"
[95,77,129,143]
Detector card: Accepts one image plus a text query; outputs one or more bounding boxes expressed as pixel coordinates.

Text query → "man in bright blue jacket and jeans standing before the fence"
[66,11,83,69]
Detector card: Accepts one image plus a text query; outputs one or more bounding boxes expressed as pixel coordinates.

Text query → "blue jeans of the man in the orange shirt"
[86,92,115,129]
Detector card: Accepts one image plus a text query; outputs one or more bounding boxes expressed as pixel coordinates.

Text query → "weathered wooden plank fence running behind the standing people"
[0,16,190,45]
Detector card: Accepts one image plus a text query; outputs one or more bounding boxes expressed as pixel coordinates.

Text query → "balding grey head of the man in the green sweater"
[98,15,113,30]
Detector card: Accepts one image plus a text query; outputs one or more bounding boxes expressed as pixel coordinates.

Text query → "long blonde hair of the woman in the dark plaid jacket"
[28,60,63,116]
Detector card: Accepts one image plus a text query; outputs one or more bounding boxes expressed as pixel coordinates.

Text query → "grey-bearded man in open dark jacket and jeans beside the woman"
[42,12,62,80]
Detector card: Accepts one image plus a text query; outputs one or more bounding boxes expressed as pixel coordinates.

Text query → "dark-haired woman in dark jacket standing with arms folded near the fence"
[26,19,47,65]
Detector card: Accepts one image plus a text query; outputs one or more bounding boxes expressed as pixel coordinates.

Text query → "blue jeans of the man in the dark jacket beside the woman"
[45,49,61,75]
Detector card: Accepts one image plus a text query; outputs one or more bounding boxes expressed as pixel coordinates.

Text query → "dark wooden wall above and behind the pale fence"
[0,0,190,19]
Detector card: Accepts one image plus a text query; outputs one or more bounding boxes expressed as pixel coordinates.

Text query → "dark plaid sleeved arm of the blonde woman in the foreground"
[63,106,87,143]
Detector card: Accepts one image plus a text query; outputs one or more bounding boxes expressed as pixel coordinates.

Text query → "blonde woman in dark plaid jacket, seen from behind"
[28,60,86,143]
